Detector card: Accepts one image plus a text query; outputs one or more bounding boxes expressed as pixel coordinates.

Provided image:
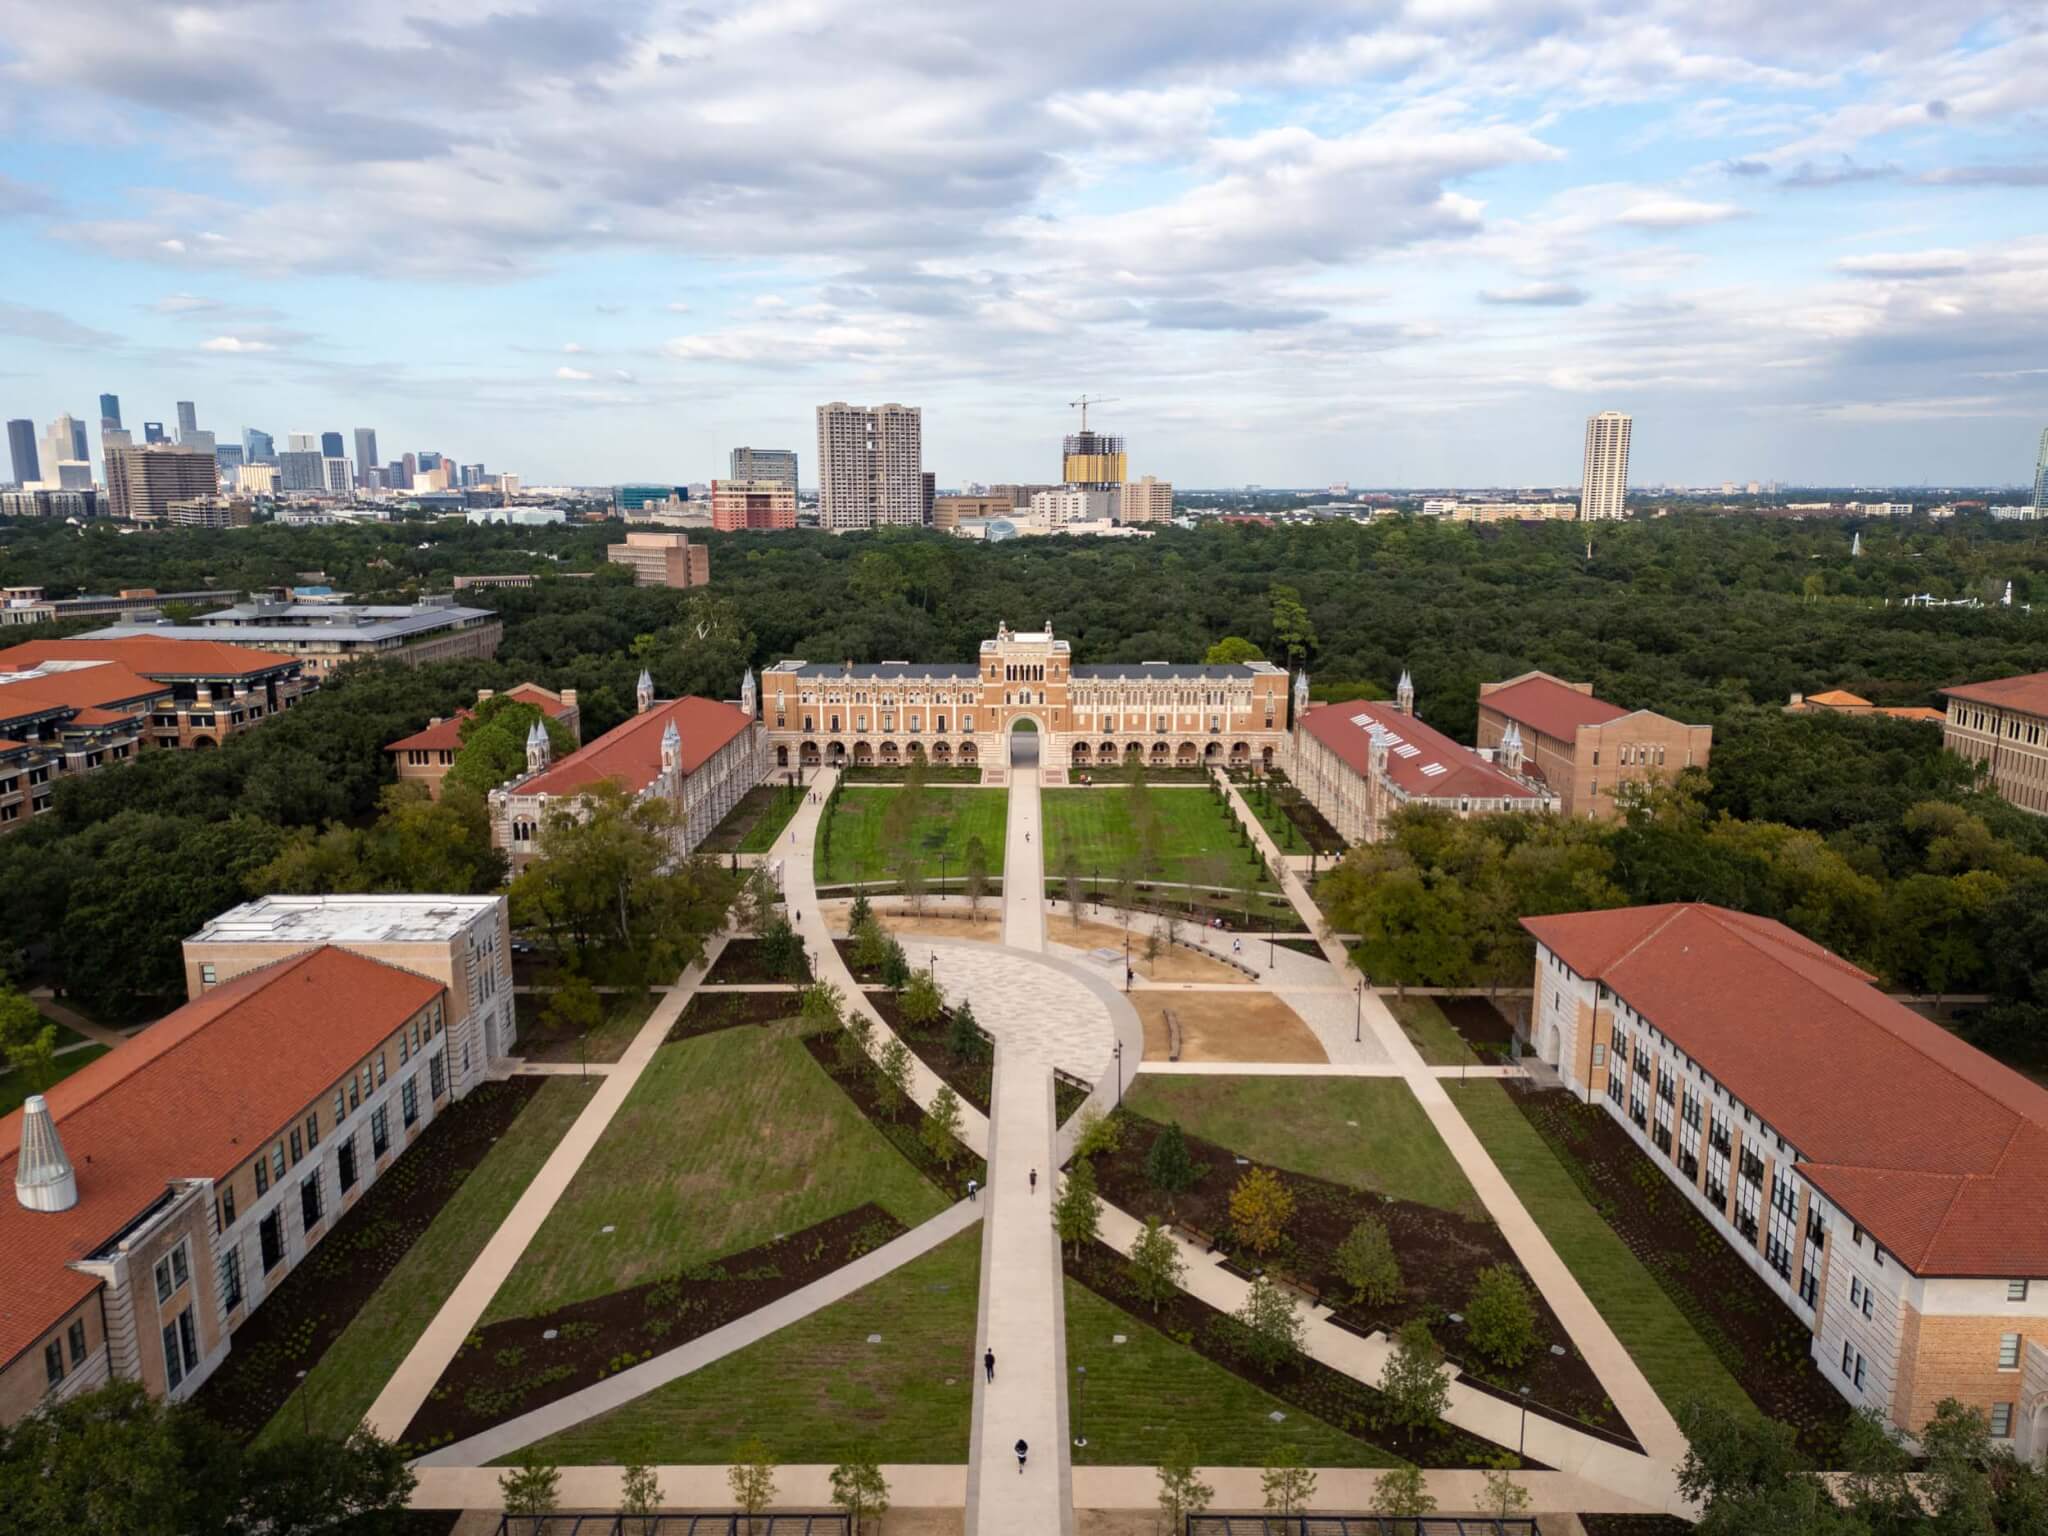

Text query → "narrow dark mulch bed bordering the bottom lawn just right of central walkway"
[1061,1245,1536,1466]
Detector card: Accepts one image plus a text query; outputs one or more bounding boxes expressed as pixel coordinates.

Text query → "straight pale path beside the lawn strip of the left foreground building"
[362,934,725,1440]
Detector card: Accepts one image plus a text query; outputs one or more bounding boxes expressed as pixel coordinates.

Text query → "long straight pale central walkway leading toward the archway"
[967,741,1073,1536]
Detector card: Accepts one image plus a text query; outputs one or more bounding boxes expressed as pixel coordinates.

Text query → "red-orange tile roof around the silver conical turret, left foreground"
[0,946,442,1364]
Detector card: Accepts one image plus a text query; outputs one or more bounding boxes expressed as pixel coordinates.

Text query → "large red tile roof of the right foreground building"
[1522,903,2048,1276]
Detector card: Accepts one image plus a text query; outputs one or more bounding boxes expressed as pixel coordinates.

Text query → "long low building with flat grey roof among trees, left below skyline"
[86,600,504,678]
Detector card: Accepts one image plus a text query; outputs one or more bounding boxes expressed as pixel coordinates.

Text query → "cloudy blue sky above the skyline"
[0,0,2048,487]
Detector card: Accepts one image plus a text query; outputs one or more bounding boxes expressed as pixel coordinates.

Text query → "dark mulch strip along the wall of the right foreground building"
[1501,1081,1849,1462]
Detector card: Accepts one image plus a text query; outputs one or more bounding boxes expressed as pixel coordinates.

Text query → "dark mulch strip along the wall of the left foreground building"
[193,1077,543,1438]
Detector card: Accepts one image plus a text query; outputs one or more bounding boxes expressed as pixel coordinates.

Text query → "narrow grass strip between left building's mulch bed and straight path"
[258,1077,600,1444]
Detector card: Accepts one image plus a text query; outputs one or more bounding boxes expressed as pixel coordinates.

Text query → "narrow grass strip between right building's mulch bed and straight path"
[1444,1079,1757,1413]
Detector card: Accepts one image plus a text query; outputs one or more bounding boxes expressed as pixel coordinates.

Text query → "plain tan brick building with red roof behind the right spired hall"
[1477,672,1714,821]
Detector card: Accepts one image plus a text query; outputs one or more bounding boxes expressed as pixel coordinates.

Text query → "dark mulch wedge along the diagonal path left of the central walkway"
[399,1202,909,1454]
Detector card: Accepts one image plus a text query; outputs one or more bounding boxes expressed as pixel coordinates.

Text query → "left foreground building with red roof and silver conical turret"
[0,946,479,1423]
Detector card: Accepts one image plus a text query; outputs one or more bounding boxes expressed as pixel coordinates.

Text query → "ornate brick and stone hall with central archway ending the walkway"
[762,623,1286,784]
